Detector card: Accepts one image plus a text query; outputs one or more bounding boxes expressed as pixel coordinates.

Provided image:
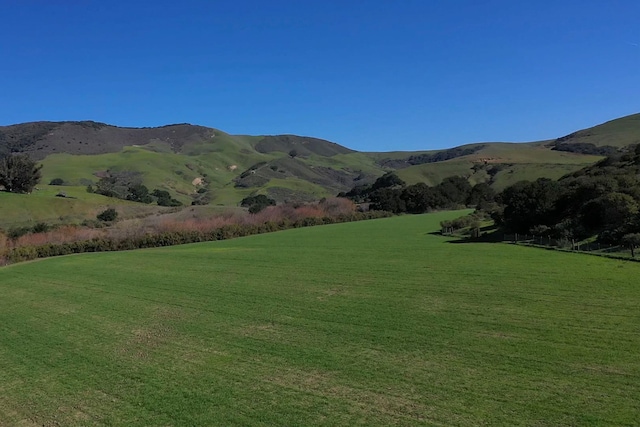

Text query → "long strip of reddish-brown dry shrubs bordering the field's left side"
[0,198,378,265]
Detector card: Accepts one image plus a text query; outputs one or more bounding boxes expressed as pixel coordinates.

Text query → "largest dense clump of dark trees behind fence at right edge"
[491,145,640,243]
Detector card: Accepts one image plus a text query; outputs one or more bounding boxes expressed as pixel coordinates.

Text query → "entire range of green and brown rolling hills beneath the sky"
[0,114,640,227]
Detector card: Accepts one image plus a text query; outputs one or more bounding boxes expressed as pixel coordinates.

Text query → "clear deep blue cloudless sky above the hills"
[0,0,640,151]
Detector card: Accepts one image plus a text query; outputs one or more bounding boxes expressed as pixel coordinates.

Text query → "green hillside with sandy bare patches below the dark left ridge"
[42,133,390,209]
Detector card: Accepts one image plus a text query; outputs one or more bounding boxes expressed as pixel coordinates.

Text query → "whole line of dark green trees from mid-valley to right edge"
[339,144,640,249]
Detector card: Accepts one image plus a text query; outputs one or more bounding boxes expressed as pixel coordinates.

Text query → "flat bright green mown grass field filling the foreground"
[0,216,640,426]
